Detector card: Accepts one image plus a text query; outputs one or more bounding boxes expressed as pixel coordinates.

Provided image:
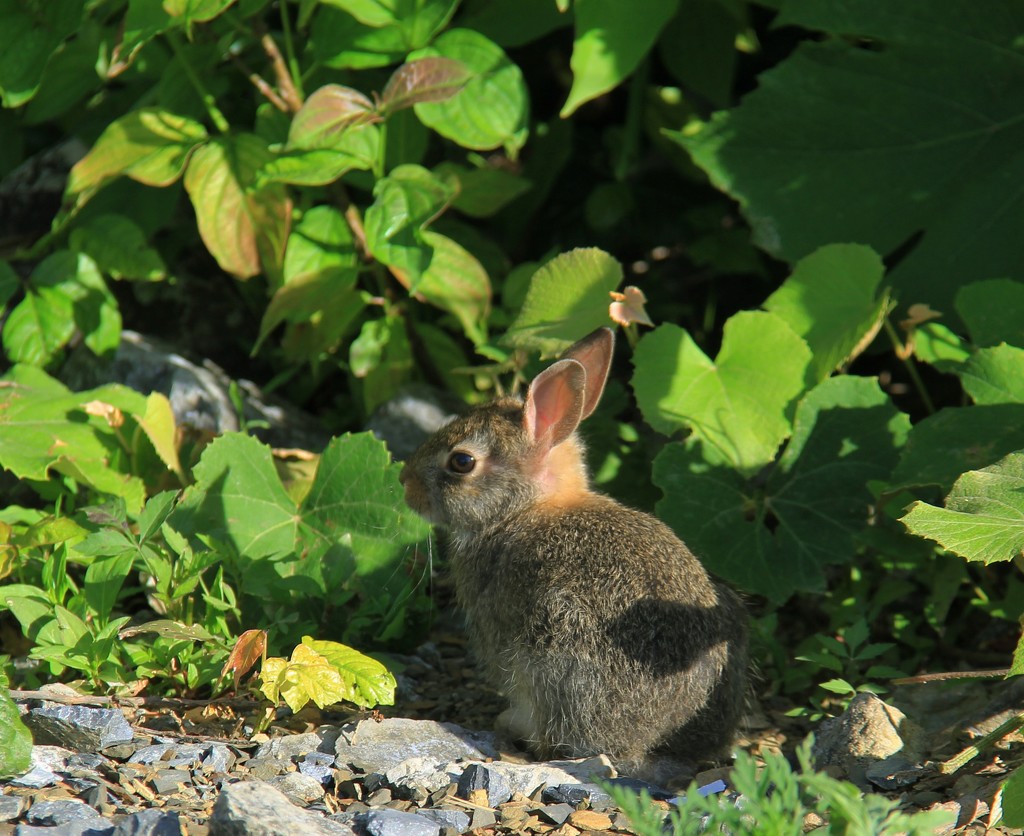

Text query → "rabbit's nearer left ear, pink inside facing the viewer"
[522,360,587,453]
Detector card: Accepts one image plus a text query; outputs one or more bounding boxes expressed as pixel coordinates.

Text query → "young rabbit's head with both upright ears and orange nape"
[401,328,614,534]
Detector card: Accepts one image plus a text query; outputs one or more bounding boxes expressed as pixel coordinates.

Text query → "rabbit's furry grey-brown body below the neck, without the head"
[451,493,745,760]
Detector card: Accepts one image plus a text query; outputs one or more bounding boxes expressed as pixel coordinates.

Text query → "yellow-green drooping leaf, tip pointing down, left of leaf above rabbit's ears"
[416,229,490,345]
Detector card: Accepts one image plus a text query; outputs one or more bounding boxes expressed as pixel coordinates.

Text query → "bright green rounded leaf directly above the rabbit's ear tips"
[502,247,623,357]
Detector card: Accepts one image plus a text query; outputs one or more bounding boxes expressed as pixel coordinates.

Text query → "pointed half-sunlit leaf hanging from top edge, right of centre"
[561,0,679,119]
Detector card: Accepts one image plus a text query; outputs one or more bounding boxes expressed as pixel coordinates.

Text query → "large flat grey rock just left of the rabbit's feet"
[337,718,498,772]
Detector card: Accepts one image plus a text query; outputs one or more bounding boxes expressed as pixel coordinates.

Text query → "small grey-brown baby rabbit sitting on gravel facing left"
[400,328,746,771]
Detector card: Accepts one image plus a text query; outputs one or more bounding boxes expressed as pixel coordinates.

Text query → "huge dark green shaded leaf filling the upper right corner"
[673,0,1024,323]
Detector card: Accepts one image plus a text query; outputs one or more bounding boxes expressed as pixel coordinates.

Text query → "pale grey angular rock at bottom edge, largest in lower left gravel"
[208,781,355,836]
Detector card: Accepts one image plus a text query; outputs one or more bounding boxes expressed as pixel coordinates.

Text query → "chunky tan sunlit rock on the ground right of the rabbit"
[813,694,924,790]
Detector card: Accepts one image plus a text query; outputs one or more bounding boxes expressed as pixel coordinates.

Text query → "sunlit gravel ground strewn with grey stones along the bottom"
[0,634,1019,836]
